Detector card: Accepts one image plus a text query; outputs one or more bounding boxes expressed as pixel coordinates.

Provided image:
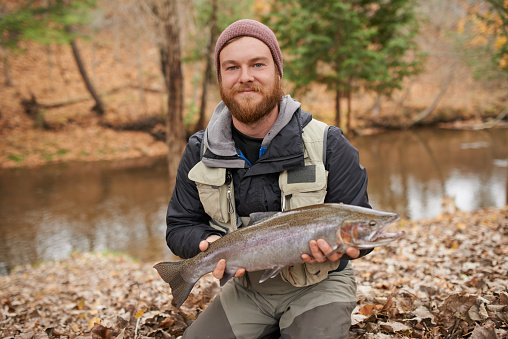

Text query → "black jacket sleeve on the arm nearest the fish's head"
[325,126,372,260]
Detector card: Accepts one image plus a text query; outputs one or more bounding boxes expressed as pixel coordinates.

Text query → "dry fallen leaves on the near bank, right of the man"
[351,206,508,338]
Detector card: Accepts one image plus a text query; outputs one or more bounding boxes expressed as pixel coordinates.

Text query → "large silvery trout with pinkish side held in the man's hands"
[154,203,405,308]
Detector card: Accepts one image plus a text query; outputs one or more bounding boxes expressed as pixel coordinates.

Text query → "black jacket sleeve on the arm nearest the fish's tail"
[166,132,223,259]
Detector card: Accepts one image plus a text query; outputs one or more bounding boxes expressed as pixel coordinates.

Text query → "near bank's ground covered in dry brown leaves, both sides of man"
[0,206,508,339]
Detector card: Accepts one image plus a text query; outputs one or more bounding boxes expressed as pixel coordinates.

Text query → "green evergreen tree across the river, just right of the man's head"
[265,0,418,129]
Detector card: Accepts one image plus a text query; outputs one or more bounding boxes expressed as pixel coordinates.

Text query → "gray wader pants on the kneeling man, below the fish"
[183,264,356,339]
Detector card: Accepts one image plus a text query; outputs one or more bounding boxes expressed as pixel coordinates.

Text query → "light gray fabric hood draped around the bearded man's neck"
[205,94,301,157]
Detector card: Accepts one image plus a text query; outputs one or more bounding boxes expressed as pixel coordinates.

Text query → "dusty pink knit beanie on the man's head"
[215,19,282,78]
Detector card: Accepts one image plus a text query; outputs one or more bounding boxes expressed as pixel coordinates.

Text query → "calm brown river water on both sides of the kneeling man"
[0,129,508,266]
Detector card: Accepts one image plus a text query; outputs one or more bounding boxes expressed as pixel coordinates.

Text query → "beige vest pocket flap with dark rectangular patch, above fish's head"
[279,164,327,195]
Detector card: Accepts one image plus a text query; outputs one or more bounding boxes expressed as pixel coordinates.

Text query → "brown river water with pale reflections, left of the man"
[0,159,173,264]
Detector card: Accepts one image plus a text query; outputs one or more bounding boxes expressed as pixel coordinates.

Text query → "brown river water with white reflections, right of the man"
[358,129,508,219]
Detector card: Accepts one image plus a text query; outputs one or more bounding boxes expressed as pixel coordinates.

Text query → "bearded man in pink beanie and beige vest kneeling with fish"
[166,20,370,339]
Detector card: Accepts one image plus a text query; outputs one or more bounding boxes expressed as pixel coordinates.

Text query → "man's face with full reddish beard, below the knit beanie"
[219,37,283,124]
